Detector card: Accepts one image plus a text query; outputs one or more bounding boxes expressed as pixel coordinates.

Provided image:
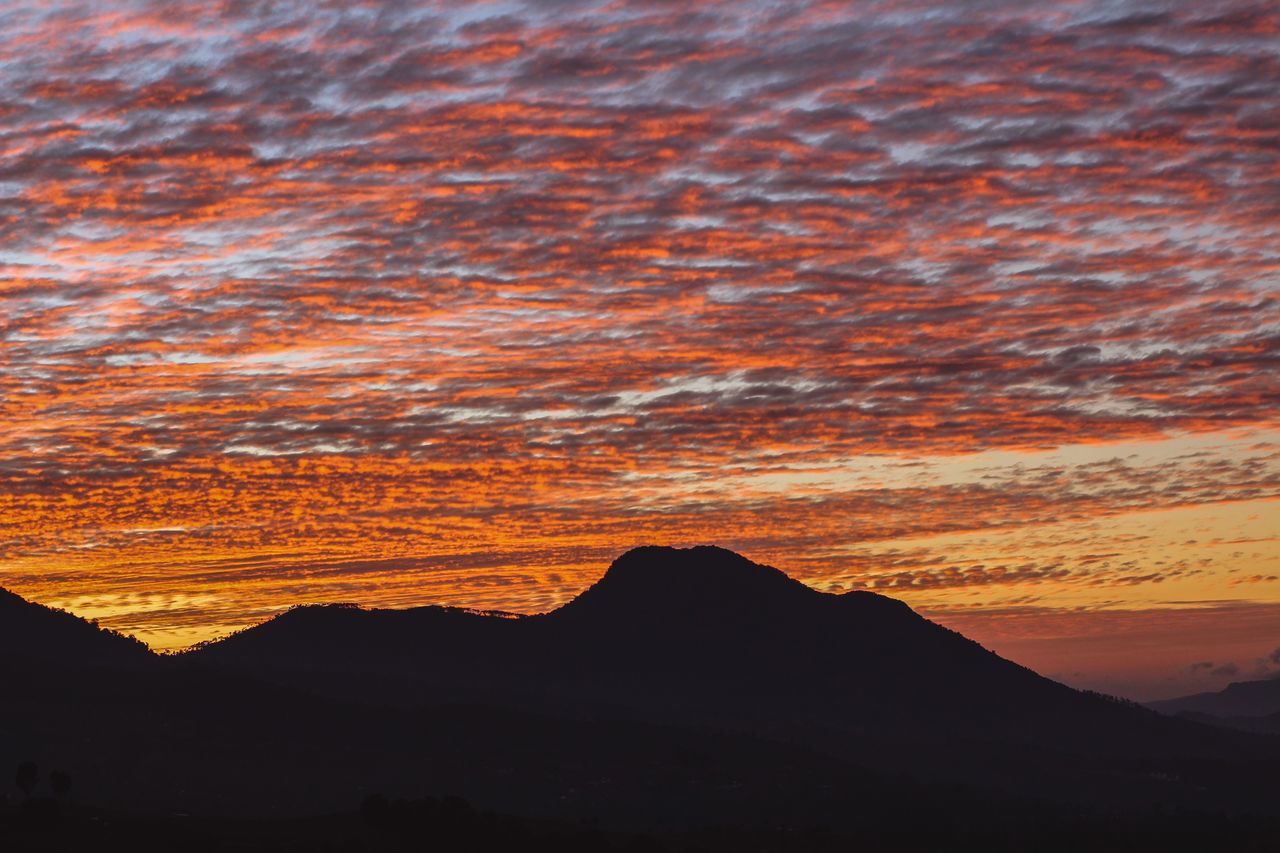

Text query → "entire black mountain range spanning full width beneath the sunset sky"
[0,547,1280,826]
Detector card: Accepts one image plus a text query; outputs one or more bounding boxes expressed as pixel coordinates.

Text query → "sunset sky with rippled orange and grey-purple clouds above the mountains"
[0,0,1280,699]
